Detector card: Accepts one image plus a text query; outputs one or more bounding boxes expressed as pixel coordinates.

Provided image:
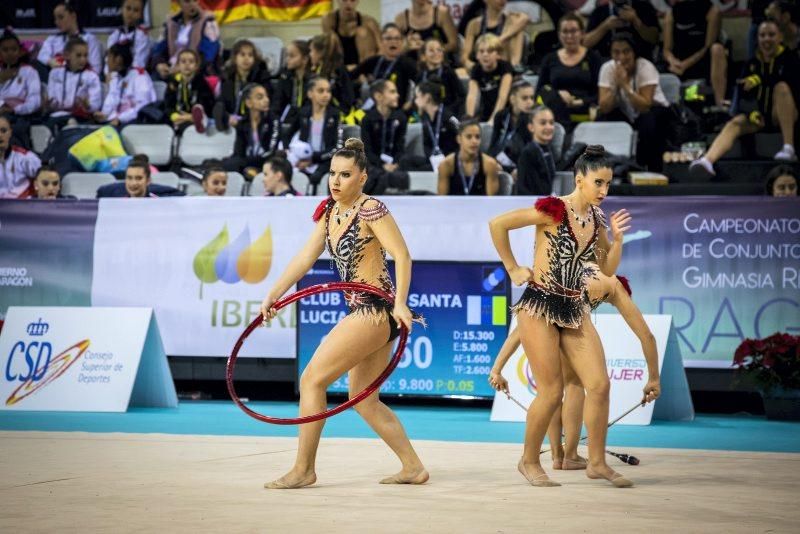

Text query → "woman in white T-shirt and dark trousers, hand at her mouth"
[597,33,669,171]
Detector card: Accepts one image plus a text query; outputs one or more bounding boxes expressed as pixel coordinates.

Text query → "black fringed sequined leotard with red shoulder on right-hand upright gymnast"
[513,197,606,328]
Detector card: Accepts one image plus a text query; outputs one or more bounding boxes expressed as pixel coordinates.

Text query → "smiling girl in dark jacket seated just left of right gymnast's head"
[514,106,556,196]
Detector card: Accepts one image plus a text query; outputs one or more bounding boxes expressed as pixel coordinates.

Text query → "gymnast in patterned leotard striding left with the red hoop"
[261,138,428,489]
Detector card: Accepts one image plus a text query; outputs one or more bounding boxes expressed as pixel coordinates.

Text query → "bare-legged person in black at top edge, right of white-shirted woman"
[664,0,728,106]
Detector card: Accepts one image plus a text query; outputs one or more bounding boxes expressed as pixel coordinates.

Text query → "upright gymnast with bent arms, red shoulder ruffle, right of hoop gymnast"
[489,146,633,487]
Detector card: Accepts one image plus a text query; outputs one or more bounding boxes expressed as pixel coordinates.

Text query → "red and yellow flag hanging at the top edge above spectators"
[177,0,332,24]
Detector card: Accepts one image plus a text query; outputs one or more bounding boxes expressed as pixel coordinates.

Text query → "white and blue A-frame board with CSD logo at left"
[0,307,177,411]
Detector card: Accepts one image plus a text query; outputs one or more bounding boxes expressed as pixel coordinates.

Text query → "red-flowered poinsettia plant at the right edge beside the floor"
[733,332,800,391]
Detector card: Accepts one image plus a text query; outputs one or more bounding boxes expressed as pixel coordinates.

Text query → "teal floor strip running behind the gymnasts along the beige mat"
[0,401,800,453]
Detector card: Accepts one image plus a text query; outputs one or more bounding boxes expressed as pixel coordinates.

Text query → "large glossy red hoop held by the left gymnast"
[225,282,408,425]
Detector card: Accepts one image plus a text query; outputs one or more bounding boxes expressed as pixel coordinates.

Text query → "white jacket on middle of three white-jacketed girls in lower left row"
[47,67,103,117]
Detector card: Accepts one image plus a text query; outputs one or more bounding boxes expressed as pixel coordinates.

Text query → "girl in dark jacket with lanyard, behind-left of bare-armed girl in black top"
[400,80,459,171]
